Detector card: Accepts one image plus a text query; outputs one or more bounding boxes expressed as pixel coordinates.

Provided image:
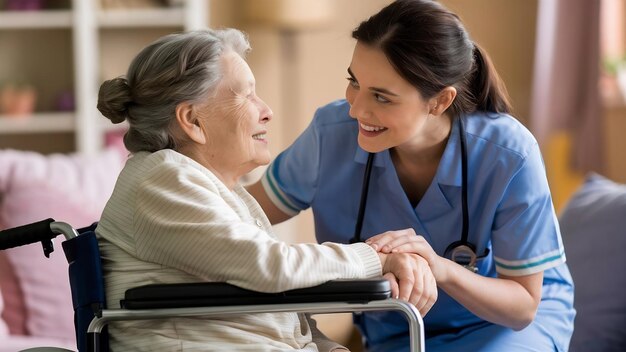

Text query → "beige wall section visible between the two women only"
[211,0,390,242]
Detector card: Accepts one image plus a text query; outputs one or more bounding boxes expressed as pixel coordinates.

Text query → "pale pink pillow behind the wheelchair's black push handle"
[0,150,125,340]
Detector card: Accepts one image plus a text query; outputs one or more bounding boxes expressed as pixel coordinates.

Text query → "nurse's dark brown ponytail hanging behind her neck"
[468,43,512,113]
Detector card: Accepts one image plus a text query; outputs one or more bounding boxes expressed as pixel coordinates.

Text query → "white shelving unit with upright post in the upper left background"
[0,0,210,154]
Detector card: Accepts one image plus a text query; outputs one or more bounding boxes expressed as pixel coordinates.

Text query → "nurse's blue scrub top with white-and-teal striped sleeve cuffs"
[262,100,574,350]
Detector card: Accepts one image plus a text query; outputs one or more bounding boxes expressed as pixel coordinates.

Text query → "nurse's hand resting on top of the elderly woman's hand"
[365,228,446,281]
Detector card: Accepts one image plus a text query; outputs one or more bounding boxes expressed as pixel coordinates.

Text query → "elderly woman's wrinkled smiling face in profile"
[198,52,272,176]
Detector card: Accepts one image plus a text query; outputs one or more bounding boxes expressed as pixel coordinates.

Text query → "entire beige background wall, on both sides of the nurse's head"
[211,0,537,241]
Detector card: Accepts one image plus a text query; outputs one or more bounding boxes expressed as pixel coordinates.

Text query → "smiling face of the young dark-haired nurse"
[346,42,430,152]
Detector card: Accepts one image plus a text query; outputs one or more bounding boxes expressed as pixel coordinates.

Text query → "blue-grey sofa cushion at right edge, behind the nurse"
[559,174,626,352]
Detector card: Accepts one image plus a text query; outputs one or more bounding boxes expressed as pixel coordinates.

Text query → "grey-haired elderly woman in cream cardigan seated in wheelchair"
[96,29,437,351]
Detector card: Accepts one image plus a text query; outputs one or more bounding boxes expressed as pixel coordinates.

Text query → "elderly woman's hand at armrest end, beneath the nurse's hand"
[379,253,438,316]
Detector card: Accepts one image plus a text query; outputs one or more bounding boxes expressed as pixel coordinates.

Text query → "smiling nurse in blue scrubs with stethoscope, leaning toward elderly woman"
[250,0,575,352]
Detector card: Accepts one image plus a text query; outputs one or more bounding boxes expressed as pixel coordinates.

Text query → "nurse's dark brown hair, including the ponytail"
[352,0,511,116]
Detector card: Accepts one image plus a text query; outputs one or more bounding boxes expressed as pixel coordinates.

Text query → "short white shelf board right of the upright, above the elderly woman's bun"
[98,7,185,28]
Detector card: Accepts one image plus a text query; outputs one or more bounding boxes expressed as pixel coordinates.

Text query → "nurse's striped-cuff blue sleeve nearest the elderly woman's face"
[261,115,320,216]
